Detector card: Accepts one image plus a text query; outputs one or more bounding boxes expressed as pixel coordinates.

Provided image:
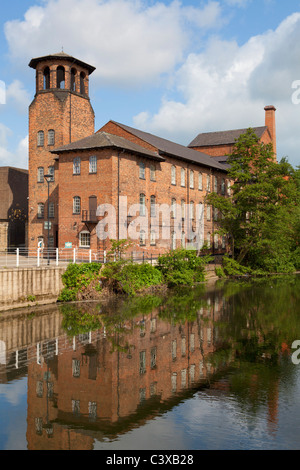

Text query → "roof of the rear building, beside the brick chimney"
[188,126,268,148]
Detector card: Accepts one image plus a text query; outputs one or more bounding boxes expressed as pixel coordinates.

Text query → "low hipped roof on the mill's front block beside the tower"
[51,132,165,161]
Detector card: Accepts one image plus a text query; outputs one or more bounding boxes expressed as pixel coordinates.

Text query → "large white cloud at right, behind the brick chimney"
[134,13,300,164]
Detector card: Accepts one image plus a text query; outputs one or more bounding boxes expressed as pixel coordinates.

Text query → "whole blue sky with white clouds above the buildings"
[0,0,300,168]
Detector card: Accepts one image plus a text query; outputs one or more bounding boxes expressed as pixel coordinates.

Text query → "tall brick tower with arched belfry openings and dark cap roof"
[28,52,95,250]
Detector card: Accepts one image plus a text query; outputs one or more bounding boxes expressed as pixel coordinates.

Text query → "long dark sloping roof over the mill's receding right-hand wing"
[111,121,226,171]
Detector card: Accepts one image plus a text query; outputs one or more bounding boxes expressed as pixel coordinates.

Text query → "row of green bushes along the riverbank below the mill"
[58,249,210,302]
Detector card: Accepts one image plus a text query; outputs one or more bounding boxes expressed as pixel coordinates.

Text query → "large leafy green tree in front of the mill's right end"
[208,129,300,272]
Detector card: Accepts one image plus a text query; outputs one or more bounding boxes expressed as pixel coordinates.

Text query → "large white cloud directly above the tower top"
[5,0,222,85]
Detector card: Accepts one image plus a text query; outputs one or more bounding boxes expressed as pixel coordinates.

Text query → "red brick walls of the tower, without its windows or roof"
[28,57,94,249]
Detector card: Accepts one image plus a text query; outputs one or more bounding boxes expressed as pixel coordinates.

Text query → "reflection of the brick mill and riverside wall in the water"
[0,296,225,449]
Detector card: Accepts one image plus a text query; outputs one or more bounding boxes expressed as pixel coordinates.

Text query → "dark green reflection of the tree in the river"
[213,276,300,431]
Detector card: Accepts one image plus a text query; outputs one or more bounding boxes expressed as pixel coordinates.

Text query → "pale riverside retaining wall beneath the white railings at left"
[0,267,66,312]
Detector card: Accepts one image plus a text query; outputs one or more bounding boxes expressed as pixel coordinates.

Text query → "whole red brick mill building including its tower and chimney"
[28,52,276,254]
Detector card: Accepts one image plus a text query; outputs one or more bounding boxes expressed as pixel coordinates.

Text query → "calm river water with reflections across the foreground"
[0,276,300,451]
